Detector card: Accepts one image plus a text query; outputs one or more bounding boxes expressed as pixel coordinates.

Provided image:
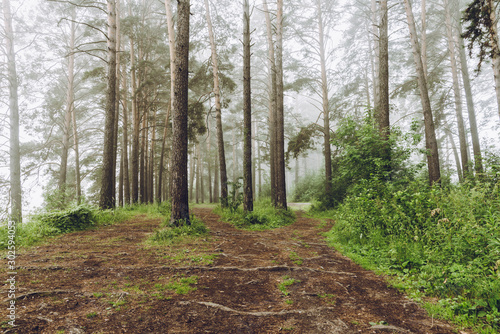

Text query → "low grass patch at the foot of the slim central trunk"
[215,199,295,230]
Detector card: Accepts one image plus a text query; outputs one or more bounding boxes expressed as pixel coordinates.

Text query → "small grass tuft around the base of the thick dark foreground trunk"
[149,216,208,244]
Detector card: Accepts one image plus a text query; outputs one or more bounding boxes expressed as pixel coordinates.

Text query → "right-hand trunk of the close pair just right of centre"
[276,0,288,209]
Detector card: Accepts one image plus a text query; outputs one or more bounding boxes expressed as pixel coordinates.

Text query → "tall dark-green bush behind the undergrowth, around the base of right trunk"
[315,112,421,211]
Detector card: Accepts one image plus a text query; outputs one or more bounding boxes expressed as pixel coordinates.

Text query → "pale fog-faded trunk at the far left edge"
[3,0,22,223]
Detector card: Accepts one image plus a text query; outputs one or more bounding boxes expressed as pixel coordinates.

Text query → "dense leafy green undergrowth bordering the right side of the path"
[328,178,500,330]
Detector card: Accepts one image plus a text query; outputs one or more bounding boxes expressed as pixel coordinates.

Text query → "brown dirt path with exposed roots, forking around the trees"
[0,209,460,333]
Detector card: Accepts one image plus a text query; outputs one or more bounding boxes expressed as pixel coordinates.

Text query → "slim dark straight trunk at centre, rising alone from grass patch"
[243,0,253,211]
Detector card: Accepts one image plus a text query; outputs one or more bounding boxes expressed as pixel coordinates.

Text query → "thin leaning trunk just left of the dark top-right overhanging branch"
[455,3,484,175]
